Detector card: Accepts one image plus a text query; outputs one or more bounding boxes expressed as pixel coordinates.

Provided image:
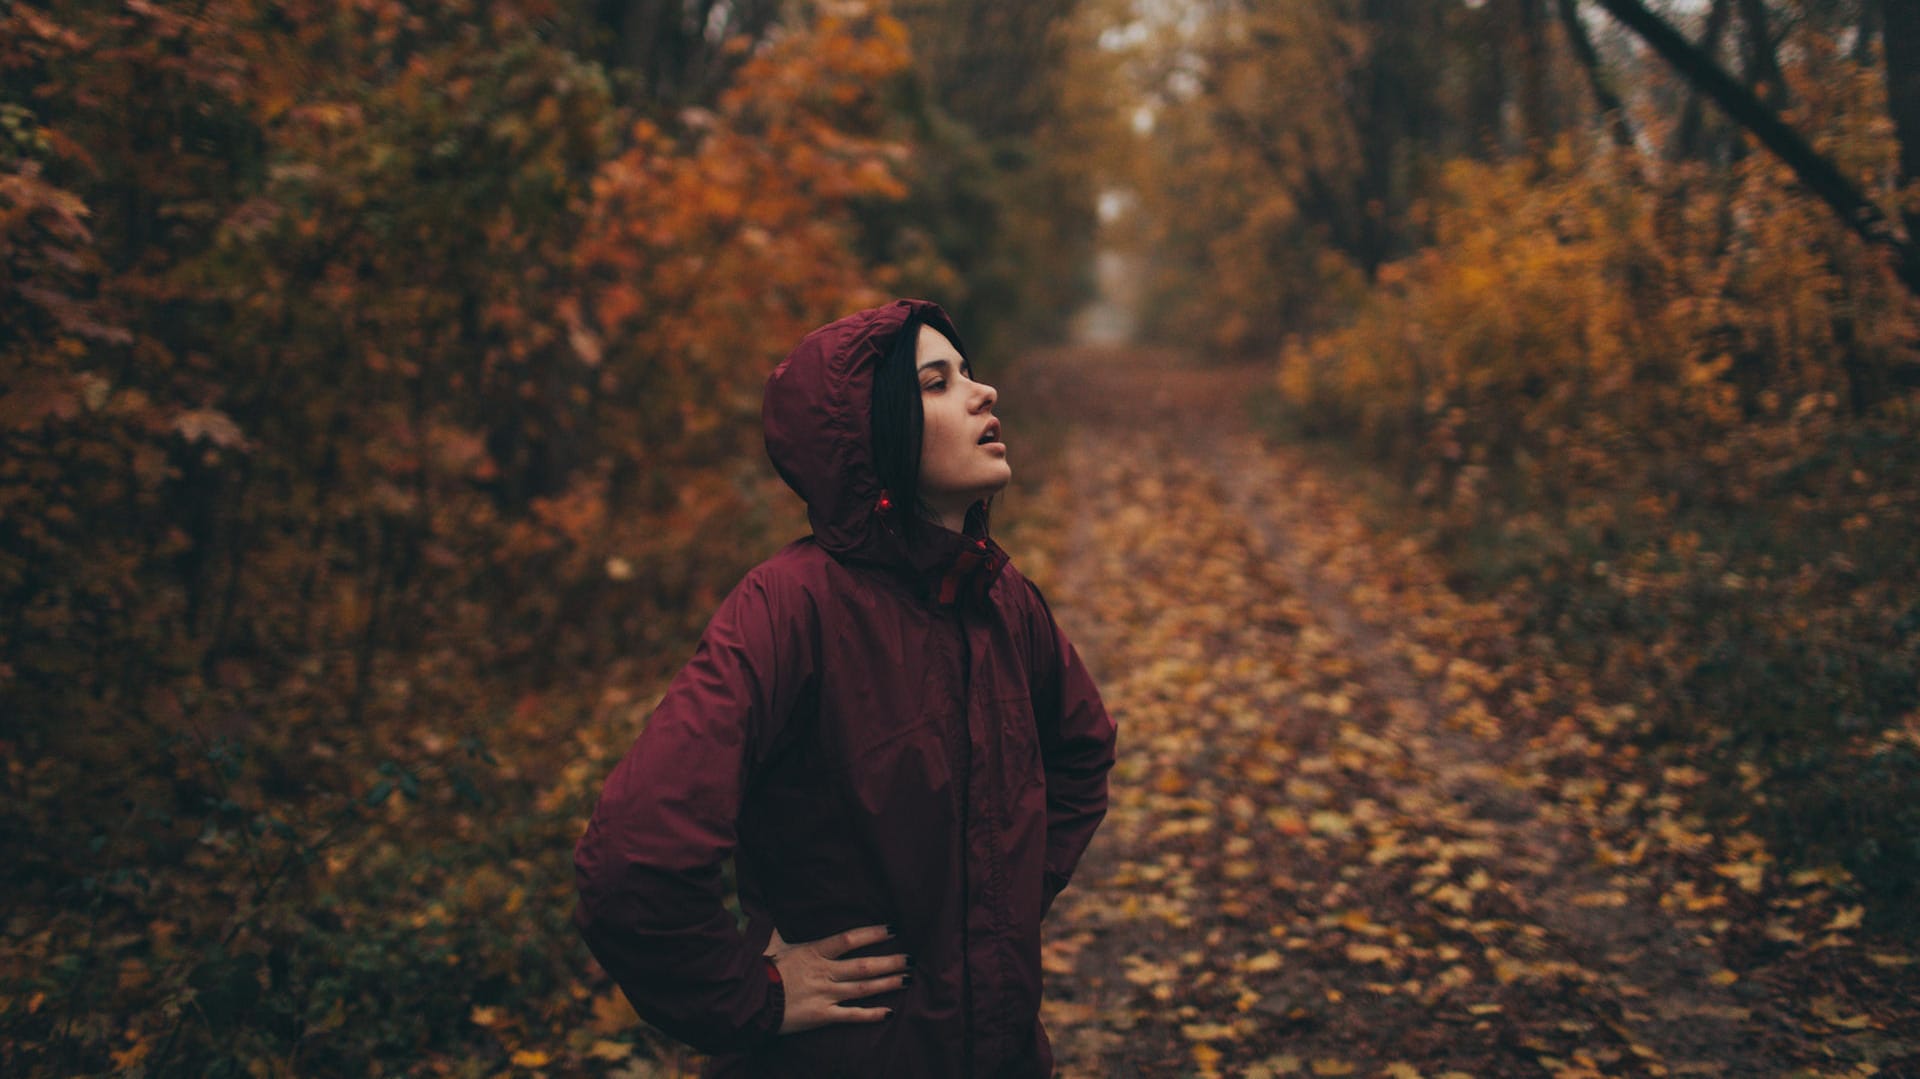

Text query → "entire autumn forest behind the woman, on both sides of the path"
[0,0,1920,1075]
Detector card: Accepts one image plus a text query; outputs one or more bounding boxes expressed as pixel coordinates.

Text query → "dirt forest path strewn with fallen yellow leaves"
[1008,349,1896,1077]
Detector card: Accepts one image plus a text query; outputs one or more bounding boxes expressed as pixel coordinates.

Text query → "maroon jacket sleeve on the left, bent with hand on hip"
[574,574,814,1052]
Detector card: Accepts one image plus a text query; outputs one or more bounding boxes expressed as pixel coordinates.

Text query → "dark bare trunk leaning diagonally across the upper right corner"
[1599,0,1920,296]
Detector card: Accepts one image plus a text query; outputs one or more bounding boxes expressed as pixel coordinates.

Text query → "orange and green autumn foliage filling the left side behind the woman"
[0,0,948,1075]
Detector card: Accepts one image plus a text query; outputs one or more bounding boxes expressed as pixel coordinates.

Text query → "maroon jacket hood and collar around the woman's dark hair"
[760,300,1006,603]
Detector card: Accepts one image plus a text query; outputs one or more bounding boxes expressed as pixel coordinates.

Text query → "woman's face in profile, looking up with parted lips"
[914,318,1014,532]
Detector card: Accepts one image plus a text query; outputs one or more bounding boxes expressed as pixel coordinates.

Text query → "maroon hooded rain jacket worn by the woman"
[574,300,1114,1077]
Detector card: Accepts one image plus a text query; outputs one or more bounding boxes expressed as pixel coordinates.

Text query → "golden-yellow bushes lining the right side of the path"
[1167,8,1920,927]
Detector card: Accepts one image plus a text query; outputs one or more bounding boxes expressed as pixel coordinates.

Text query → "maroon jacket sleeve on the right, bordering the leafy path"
[1027,580,1116,918]
